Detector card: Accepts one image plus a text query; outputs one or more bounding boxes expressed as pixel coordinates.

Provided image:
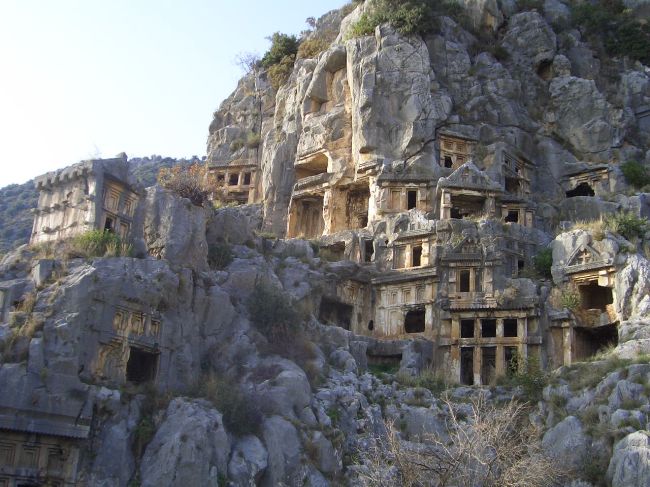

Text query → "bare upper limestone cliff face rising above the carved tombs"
[208,2,650,235]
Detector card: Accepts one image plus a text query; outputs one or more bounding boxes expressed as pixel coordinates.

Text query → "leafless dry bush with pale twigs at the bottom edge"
[359,395,568,487]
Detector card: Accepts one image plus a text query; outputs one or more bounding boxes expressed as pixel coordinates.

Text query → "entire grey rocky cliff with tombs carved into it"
[0,0,650,487]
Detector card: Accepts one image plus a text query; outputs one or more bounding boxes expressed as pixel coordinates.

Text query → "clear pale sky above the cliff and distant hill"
[0,0,347,187]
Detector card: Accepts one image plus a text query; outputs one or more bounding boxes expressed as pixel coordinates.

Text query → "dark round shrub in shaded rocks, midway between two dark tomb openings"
[247,282,301,342]
